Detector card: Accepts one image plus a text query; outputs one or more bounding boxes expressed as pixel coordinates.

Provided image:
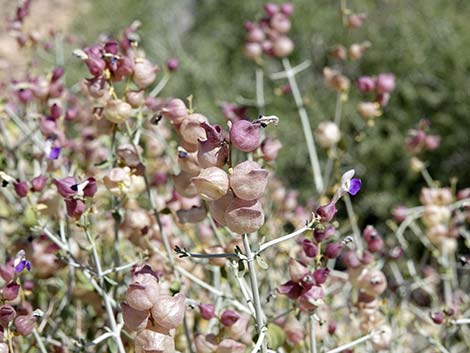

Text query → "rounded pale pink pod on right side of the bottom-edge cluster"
[151,293,186,330]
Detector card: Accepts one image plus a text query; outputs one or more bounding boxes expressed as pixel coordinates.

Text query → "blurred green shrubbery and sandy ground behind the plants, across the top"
[0,0,470,223]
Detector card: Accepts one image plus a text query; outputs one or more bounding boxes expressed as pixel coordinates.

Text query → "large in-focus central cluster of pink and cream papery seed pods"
[163,99,277,234]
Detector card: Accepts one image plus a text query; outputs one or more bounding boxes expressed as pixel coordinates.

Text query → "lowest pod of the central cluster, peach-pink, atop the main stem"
[224,198,264,234]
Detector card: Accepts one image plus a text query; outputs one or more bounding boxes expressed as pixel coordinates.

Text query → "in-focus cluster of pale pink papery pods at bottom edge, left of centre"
[121,265,186,353]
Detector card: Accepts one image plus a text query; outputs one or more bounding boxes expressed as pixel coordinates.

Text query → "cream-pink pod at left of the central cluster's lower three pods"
[191,167,229,201]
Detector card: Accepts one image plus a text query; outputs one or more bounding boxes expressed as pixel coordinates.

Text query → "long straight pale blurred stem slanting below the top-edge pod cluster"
[282,58,323,193]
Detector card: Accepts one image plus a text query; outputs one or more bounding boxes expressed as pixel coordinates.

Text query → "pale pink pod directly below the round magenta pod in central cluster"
[230,160,269,201]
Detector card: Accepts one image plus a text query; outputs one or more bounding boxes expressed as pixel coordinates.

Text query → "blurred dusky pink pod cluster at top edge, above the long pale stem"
[244,3,294,60]
